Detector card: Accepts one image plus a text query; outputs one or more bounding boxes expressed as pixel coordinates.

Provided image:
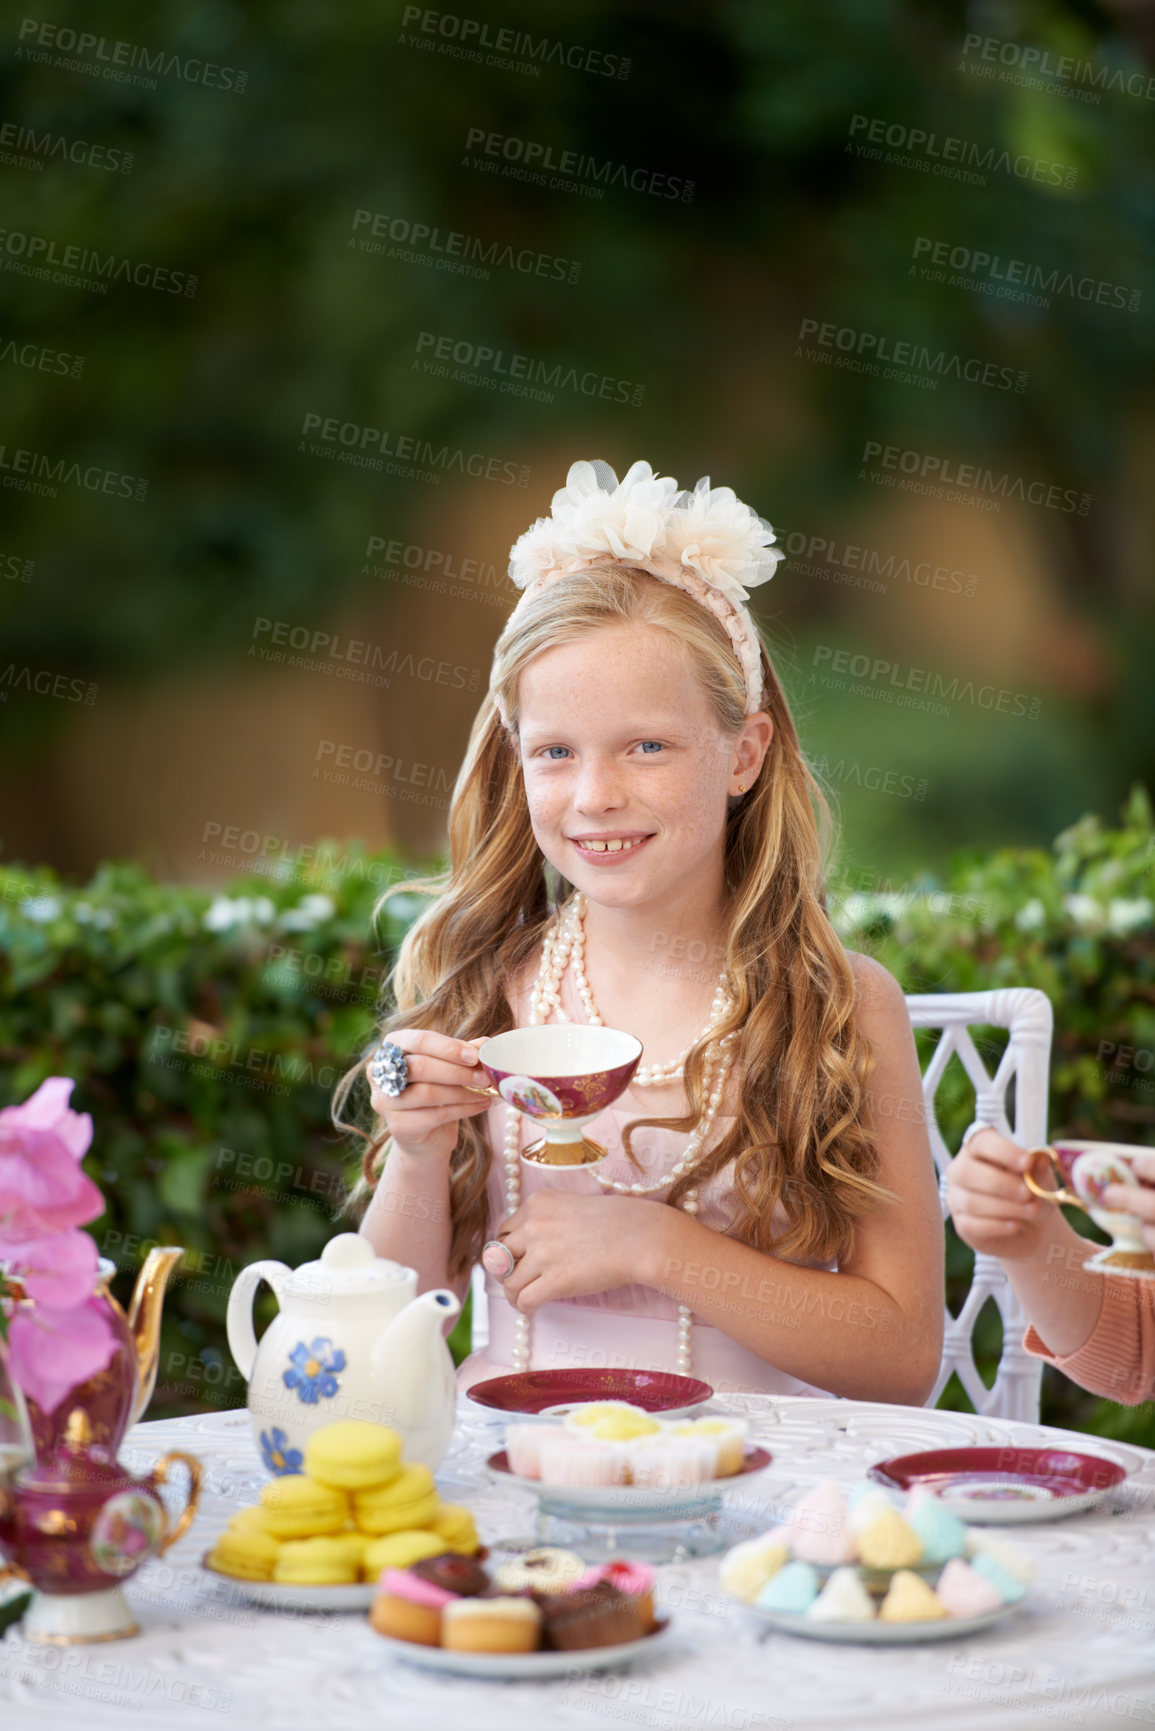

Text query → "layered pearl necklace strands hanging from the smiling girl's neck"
[502,891,738,1376]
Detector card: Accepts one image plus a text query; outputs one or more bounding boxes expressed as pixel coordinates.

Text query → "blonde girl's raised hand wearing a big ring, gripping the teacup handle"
[365,1028,492,1160]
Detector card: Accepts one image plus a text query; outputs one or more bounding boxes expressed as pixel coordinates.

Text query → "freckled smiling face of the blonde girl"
[518,625,771,912]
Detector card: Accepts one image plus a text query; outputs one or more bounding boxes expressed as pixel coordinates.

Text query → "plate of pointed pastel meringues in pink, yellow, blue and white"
[719,1480,1034,1624]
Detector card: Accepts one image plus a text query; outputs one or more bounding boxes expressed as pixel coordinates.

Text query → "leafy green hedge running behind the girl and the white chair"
[0,789,1155,1442]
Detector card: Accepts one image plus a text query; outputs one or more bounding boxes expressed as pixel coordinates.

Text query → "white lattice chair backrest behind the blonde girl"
[906,987,1053,1423]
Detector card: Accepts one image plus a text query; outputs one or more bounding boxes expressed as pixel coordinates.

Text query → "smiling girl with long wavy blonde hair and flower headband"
[339,462,944,1404]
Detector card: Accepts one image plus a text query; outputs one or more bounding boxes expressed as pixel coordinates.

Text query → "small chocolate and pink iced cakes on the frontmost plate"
[369,1548,656,1653]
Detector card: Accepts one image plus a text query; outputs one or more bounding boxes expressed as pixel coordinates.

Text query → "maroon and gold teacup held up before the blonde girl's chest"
[476,1021,642,1167]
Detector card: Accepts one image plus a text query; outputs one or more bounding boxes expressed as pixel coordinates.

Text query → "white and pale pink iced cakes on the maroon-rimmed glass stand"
[506,1400,748,1490]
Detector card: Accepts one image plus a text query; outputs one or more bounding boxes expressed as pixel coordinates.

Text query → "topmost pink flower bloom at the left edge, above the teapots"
[0,1077,104,1250]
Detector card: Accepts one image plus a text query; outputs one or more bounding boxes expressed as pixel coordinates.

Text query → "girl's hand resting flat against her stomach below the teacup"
[483,1191,665,1316]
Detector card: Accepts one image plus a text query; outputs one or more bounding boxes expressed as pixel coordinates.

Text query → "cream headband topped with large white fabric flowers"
[497,459,783,729]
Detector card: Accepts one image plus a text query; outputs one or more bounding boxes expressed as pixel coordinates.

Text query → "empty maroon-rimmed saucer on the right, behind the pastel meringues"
[869,1445,1127,1527]
